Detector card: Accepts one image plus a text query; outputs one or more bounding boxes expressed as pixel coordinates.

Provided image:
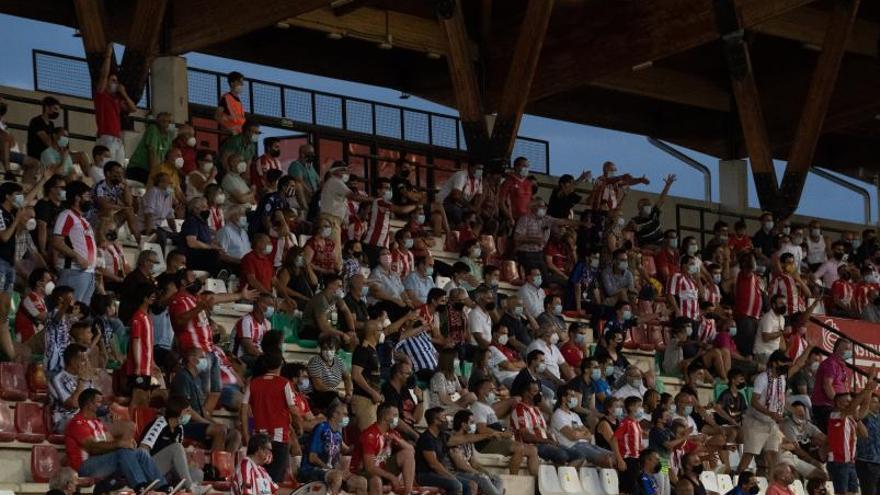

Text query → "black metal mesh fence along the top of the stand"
[33,50,550,174]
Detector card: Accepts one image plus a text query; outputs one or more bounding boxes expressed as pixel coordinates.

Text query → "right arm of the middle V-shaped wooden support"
[492,0,554,157]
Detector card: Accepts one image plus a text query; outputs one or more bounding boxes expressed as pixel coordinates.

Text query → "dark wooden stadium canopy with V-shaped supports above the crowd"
[0,0,880,215]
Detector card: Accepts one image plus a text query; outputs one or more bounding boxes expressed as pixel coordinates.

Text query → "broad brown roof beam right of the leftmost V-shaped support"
[169,0,330,54]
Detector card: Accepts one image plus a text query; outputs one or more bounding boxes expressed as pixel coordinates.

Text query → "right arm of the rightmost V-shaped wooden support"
[780,0,860,216]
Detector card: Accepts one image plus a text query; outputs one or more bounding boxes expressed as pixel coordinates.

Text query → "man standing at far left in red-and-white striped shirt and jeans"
[52,181,97,303]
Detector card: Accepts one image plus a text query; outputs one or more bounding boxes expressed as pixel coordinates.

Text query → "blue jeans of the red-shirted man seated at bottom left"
[79,449,168,488]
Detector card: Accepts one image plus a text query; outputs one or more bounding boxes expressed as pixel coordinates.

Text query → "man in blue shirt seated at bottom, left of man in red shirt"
[299,401,375,495]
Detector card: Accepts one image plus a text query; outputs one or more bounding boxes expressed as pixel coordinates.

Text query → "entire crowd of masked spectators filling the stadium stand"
[0,61,880,495]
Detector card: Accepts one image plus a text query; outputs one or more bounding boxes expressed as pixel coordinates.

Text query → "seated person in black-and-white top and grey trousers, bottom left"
[140,396,207,493]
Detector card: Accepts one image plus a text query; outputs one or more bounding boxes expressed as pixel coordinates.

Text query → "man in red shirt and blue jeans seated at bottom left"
[64,388,169,493]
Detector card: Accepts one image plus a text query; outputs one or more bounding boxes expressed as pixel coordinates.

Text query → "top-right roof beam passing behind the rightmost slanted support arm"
[752,7,880,57]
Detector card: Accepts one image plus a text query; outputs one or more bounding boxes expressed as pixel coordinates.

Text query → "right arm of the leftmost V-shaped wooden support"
[119,0,168,106]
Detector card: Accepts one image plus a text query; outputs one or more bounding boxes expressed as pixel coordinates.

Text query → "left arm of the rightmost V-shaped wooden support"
[715,0,779,215]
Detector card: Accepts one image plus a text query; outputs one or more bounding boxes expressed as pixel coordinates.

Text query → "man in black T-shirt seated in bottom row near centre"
[416,407,477,495]
